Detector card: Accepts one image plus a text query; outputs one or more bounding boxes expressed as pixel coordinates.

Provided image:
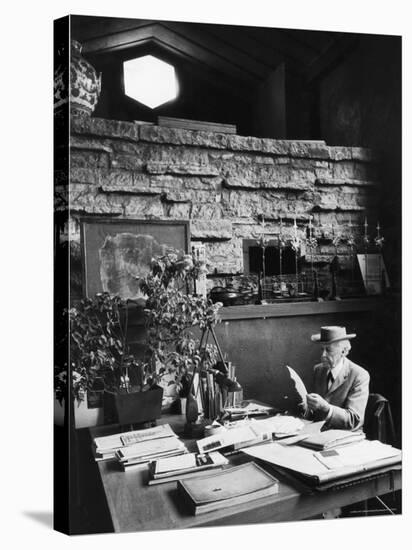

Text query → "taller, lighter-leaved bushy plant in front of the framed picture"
[140,252,221,397]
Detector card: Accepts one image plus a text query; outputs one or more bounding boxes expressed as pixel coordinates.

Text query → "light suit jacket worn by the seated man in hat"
[313,357,369,430]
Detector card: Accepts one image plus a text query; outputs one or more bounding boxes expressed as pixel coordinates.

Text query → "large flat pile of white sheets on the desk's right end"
[243,440,401,485]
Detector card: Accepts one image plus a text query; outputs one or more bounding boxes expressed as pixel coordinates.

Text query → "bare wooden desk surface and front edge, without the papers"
[91,416,401,532]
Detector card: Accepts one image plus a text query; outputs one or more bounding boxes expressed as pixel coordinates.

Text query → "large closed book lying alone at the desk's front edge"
[177,462,279,515]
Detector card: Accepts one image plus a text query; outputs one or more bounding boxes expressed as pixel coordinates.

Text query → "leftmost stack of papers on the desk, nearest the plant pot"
[94,424,177,461]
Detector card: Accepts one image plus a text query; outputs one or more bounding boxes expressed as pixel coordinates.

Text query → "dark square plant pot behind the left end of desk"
[104,386,163,425]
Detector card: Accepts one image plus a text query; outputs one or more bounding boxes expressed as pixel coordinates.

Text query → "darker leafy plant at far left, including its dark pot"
[55,292,163,430]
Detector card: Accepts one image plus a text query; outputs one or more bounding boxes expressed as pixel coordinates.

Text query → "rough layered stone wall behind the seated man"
[55,116,379,298]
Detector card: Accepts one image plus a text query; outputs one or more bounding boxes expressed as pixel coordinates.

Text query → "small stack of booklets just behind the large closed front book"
[148,452,229,485]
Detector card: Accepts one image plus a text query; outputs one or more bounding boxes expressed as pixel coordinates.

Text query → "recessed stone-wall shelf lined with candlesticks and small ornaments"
[207,215,390,307]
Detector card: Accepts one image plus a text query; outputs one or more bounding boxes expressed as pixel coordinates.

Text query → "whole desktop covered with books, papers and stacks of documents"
[90,402,401,532]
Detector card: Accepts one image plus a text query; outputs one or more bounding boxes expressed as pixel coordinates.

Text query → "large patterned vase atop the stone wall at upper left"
[54,40,101,116]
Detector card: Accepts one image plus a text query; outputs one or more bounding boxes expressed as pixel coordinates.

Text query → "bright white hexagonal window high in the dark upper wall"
[123,55,179,109]
